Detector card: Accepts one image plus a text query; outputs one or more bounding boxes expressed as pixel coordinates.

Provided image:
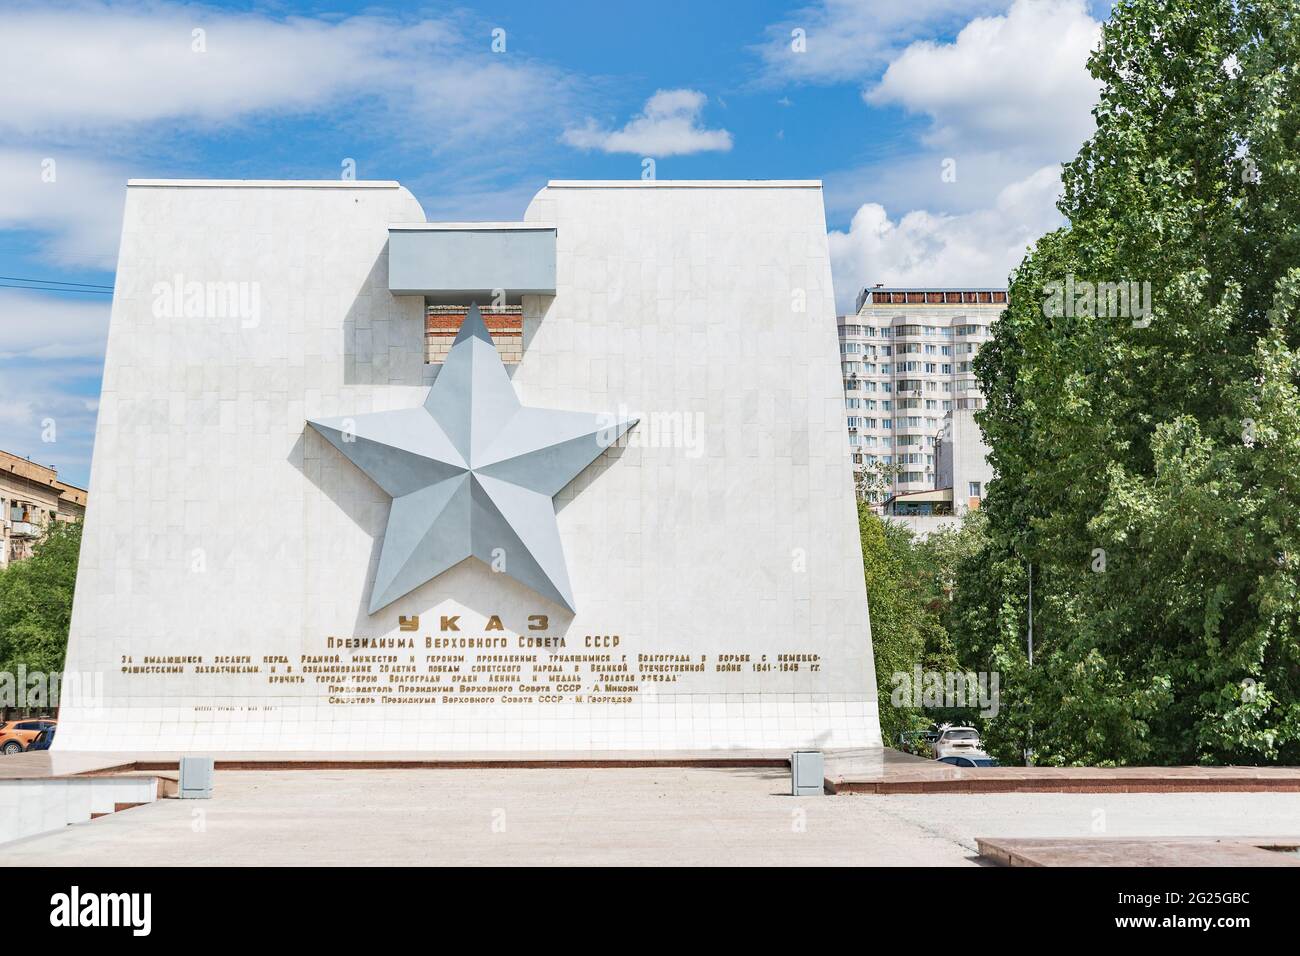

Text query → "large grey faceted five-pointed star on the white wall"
[308,306,637,614]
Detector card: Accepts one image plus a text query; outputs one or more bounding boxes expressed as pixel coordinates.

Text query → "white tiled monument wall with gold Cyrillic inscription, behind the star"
[56,181,880,753]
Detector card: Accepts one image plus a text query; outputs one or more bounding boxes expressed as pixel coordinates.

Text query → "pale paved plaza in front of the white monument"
[0,767,1300,866]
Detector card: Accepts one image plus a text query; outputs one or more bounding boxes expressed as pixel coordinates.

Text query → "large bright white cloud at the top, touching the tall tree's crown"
[865,0,1101,161]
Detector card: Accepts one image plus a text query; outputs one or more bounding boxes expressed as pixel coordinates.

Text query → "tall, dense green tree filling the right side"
[953,0,1300,763]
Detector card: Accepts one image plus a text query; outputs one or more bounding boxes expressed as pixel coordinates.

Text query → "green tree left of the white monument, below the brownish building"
[0,522,82,674]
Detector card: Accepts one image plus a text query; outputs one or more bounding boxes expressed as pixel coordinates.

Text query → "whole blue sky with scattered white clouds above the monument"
[0,0,1106,484]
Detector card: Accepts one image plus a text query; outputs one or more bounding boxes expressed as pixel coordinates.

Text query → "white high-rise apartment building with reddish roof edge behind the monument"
[839,285,1006,505]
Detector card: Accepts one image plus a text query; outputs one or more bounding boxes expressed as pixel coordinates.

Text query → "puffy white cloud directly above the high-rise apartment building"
[829,165,1061,313]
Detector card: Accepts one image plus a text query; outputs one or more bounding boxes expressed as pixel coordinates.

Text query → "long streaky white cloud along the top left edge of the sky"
[0,0,568,140]
